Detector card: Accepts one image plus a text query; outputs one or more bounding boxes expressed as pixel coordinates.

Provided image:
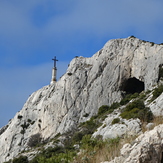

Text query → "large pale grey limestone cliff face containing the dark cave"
[0,37,163,163]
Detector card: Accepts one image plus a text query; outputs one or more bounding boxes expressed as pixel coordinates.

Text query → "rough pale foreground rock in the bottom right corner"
[105,125,163,163]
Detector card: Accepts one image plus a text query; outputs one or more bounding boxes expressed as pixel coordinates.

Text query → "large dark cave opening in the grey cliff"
[122,77,144,94]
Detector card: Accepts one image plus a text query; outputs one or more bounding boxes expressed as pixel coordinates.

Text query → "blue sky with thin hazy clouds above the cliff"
[0,0,163,127]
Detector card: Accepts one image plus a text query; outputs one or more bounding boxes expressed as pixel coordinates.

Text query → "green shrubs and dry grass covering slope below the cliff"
[4,86,163,163]
